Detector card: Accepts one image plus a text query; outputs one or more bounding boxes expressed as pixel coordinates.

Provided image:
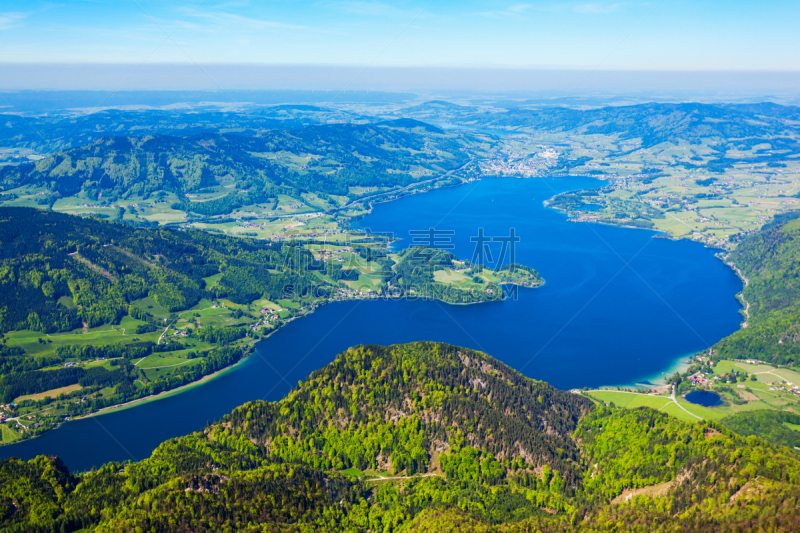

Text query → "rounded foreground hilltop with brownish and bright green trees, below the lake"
[221,343,591,484]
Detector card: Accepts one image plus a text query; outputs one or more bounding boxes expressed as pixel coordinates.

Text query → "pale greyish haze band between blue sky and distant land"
[0,63,800,103]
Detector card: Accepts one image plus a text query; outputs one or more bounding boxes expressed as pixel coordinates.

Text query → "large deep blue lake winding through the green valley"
[0,178,741,470]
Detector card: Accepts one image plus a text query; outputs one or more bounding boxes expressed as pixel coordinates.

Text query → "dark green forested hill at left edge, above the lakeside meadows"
[0,207,328,333]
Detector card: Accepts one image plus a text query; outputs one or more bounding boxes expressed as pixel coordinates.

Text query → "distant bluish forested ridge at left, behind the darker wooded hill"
[0,121,469,201]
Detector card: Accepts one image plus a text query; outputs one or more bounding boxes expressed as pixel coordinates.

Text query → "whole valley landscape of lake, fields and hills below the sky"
[0,96,800,531]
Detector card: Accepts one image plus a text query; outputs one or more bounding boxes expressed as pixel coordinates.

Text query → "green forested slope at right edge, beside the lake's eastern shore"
[715,213,800,364]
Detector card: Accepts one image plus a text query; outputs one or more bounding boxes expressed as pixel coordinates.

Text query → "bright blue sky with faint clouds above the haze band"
[0,0,800,71]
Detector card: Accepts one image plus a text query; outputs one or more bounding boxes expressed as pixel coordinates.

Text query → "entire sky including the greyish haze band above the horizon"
[0,0,800,102]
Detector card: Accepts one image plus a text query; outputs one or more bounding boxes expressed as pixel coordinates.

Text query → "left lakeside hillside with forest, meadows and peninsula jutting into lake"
[0,207,542,441]
